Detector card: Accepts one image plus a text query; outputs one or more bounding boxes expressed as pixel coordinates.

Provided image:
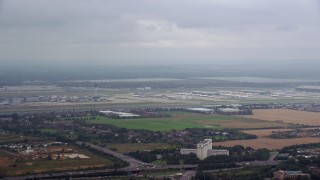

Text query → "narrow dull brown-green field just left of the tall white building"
[107,143,172,153]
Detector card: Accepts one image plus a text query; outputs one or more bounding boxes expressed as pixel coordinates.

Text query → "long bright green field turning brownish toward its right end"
[86,112,288,131]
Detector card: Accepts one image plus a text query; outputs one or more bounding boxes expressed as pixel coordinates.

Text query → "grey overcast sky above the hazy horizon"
[0,0,320,64]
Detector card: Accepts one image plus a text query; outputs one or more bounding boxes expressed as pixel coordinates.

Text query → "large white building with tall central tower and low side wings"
[180,139,229,160]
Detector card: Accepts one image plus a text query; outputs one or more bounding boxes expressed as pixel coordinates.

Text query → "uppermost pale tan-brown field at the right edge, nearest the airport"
[243,109,320,126]
